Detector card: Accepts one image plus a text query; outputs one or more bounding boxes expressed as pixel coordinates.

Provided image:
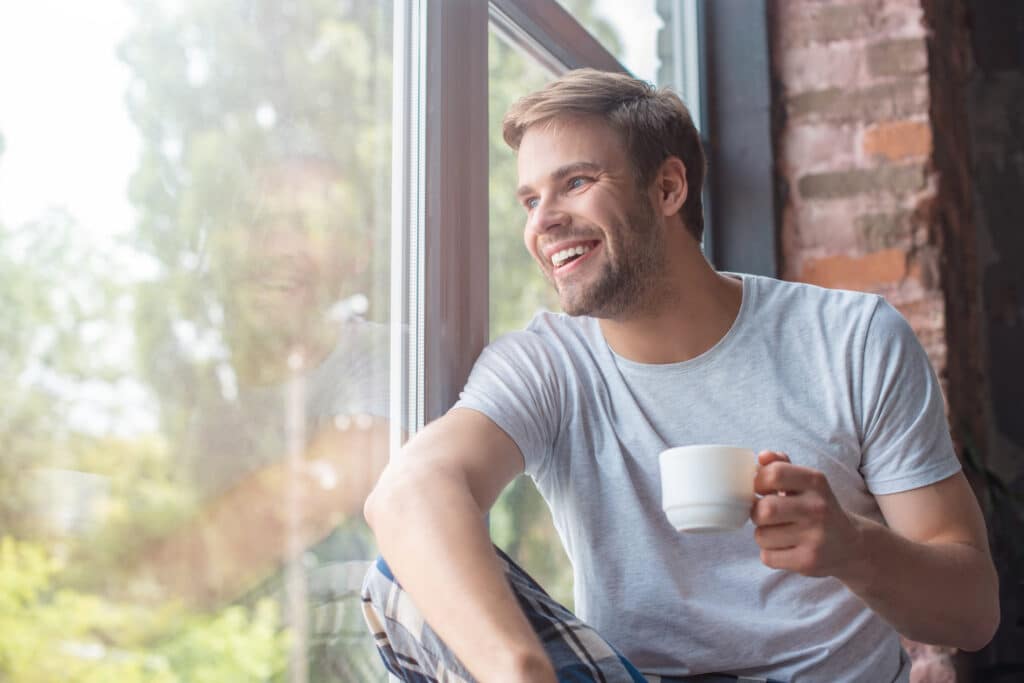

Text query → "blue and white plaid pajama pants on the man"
[362,548,779,683]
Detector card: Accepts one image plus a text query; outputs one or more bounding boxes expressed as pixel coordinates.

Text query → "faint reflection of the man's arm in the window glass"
[130,418,388,606]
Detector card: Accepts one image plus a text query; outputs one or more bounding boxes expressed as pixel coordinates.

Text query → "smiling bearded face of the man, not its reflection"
[516,118,665,318]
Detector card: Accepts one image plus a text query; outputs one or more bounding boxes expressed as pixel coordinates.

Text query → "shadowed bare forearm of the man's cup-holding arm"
[840,518,998,650]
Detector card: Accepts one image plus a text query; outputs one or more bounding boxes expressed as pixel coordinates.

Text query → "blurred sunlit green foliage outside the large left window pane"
[0,0,391,683]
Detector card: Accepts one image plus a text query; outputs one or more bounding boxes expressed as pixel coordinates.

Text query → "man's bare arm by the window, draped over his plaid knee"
[365,409,555,683]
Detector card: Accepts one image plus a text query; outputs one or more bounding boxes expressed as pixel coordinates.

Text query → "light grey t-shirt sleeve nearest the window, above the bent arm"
[454,331,564,479]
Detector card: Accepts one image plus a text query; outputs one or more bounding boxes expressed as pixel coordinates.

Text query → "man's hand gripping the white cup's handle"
[751,451,863,579]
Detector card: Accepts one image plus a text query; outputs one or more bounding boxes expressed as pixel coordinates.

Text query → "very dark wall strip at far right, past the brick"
[966,0,1024,681]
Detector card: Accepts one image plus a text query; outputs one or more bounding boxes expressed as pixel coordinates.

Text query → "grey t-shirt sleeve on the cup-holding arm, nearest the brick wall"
[861,299,961,495]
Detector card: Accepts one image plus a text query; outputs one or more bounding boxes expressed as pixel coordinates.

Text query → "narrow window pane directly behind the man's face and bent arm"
[488,32,572,607]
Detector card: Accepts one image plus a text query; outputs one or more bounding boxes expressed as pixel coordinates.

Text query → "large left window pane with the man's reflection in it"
[0,0,392,682]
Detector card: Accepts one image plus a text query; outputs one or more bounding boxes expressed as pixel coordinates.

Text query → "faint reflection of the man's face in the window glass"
[209,168,369,384]
